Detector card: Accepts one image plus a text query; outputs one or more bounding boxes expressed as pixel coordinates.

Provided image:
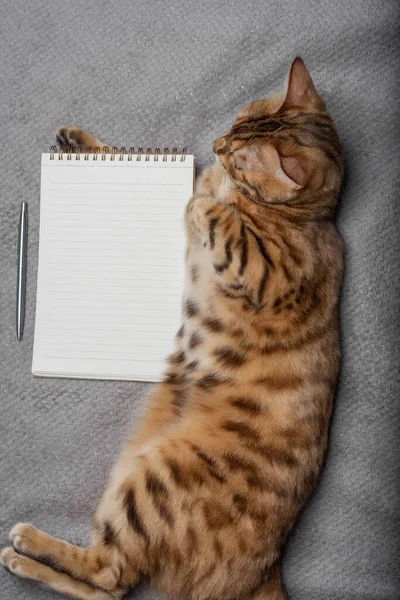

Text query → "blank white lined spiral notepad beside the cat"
[32,151,194,381]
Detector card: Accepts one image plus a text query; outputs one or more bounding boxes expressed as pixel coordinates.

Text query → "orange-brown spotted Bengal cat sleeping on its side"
[1,58,343,600]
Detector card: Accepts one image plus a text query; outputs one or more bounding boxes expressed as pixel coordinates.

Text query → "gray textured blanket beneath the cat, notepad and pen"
[0,0,400,600]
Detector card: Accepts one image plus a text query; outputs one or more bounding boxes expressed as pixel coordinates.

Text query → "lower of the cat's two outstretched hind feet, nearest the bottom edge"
[0,548,117,600]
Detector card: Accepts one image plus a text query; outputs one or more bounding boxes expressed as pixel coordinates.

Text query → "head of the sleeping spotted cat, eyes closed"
[214,58,342,204]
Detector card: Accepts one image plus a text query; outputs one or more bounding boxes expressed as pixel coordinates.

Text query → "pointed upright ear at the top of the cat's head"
[274,56,325,112]
